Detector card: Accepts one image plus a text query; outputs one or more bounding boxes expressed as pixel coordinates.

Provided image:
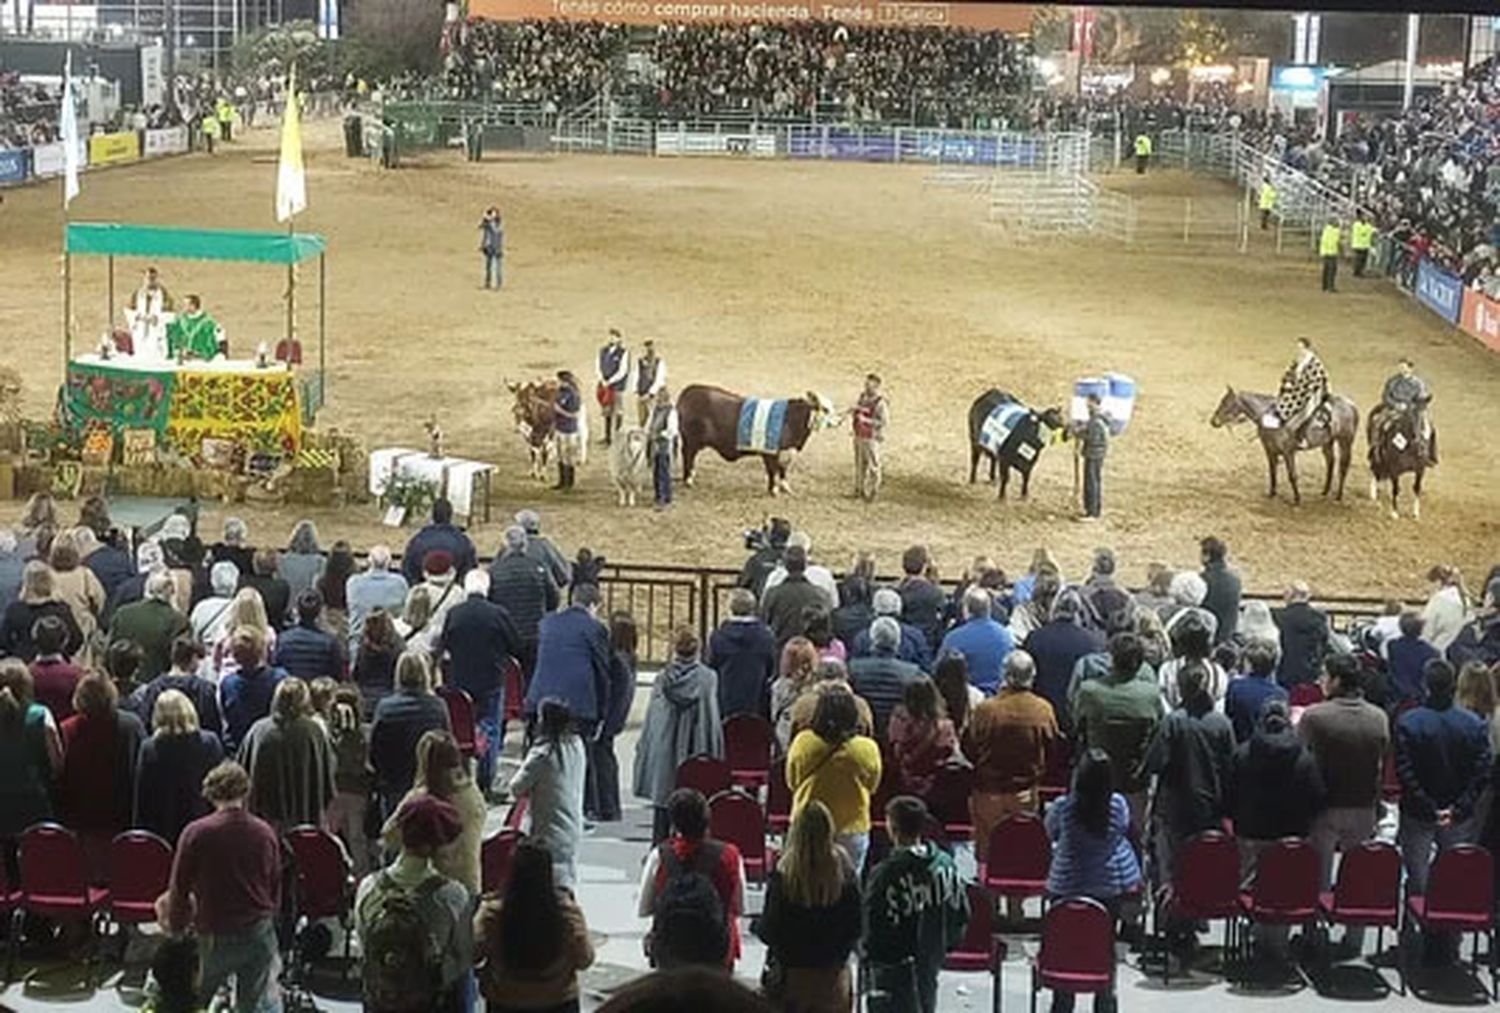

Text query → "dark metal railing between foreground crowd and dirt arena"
[591,561,1421,665]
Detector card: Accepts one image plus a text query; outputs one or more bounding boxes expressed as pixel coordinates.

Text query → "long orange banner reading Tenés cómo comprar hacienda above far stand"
[470,0,1034,33]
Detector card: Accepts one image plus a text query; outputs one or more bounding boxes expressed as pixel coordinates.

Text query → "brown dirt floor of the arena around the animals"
[0,123,1500,596]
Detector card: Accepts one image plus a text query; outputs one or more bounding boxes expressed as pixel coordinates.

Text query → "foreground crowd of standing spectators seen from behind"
[0,495,1500,1010]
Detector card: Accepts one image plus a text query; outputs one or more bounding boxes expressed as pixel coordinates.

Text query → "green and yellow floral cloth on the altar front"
[59,356,302,459]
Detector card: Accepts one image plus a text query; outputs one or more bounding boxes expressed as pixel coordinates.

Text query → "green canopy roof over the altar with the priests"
[65,222,324,264]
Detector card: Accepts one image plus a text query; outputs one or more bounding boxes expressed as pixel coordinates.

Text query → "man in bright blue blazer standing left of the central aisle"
[527,584,609,738]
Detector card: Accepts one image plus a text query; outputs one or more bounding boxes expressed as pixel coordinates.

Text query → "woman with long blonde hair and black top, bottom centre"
[755,801,864,1013]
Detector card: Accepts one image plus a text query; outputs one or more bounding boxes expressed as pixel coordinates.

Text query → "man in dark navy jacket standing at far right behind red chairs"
[1397,660,1491,894]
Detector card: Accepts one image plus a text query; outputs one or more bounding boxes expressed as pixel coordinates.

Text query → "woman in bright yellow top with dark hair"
[786,684,881,873]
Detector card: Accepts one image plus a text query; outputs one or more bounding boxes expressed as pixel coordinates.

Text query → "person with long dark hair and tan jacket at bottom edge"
[474,840,594,1013]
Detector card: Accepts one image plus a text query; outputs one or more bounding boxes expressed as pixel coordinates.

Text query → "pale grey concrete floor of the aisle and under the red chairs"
[0,690,1485,1013]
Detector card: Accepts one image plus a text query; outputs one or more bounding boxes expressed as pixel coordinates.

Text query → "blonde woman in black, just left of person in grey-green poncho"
[134,689,224,843]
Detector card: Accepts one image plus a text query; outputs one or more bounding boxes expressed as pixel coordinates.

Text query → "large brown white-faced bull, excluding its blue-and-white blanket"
[677,384,839,495]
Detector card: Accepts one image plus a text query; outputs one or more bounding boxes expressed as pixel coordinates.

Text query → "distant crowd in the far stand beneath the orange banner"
[444,20,1032,126]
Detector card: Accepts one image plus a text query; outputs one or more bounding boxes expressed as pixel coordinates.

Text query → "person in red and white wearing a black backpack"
[636,788,746,971]
